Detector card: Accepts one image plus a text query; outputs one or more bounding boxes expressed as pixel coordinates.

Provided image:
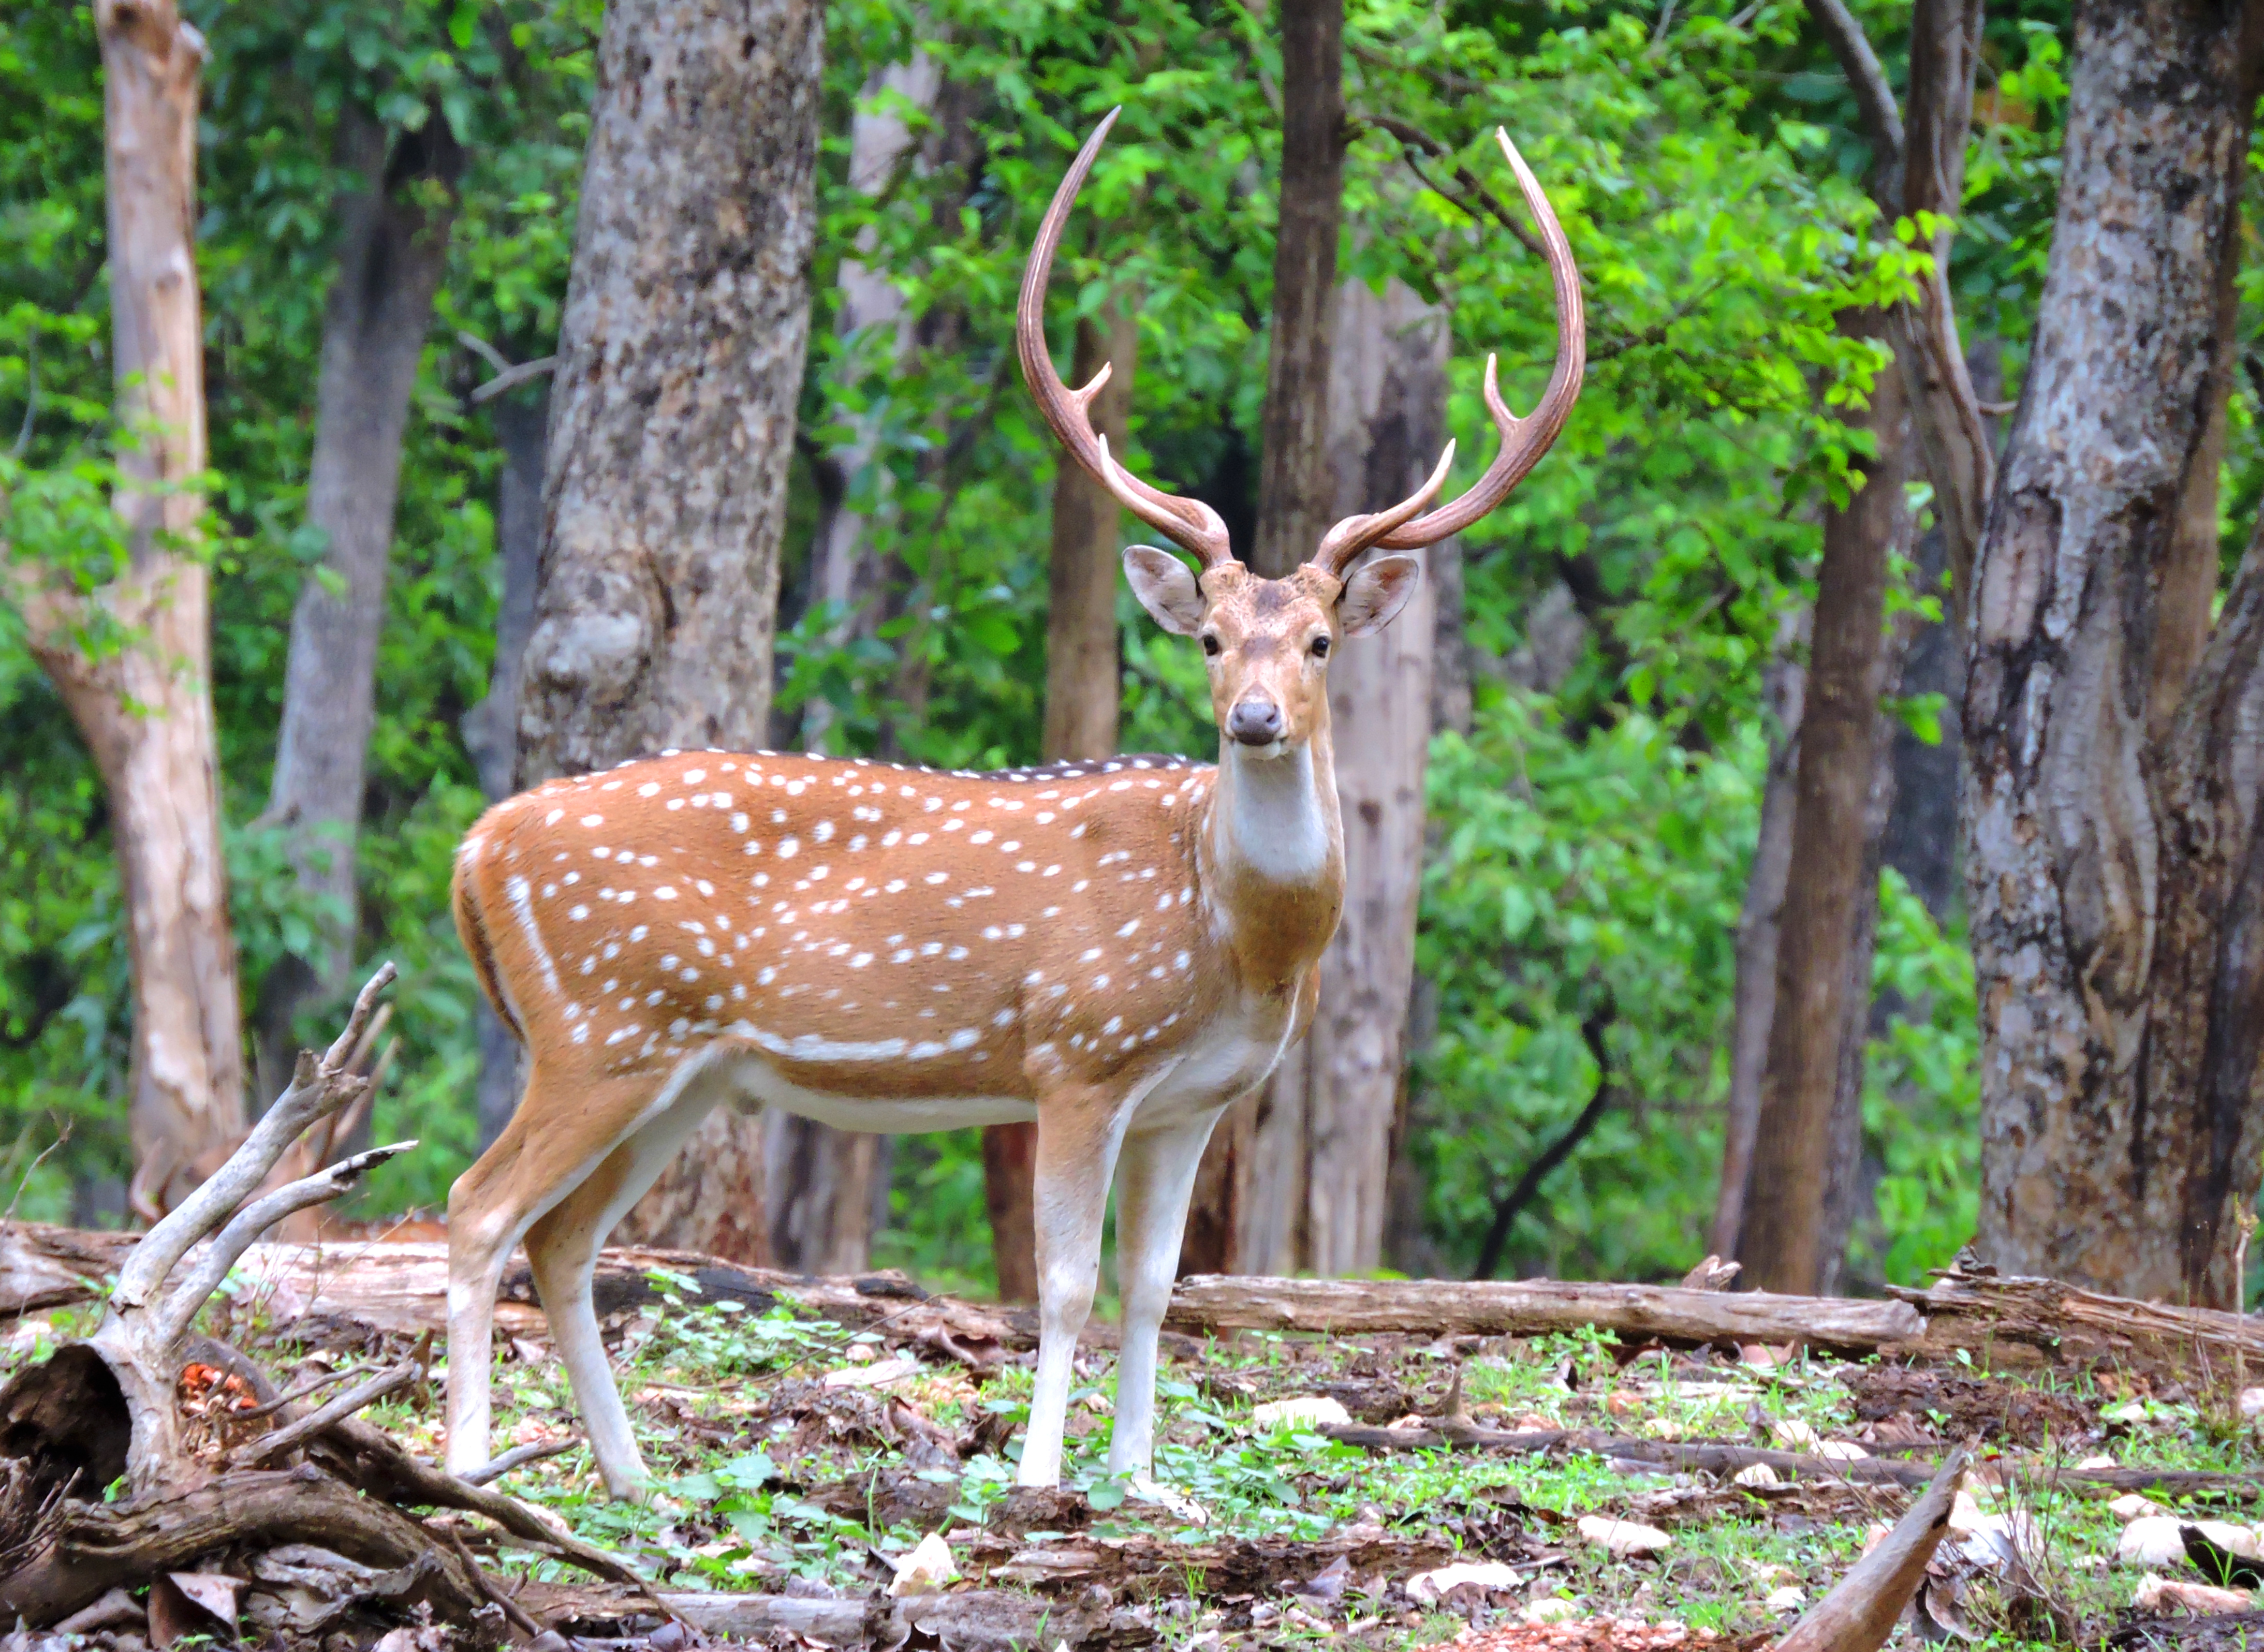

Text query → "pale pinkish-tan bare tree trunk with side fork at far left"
[9,0,244,1217]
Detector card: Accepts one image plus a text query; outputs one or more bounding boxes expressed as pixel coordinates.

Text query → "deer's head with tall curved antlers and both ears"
[1017,109,1587,758]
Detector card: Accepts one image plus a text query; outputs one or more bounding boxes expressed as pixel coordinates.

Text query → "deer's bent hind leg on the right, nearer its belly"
[527,1072,715,1500]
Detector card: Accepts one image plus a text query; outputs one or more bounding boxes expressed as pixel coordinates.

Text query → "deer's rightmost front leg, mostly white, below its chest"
[1109,1113,1218,1473]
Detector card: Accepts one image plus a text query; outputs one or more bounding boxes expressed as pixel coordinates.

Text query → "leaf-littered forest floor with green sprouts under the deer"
[13,1292,2264,1652]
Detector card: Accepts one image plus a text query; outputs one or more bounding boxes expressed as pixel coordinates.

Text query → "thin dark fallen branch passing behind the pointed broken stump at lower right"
[1313,1419,2264,1498]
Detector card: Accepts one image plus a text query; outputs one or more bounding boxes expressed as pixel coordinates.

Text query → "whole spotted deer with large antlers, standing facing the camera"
[448,113,1585,1496]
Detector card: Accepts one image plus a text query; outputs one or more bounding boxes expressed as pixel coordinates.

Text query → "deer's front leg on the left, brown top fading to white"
[1017,1091,1130,1487]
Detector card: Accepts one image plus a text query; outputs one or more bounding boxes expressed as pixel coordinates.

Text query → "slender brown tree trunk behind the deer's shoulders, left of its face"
[982,294,1139,1301]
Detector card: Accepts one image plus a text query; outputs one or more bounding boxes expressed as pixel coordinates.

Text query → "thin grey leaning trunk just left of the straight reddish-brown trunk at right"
[1707,613,1809,1256]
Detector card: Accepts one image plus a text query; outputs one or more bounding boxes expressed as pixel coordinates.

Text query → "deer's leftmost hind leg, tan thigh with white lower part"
[448,1061,656,1473]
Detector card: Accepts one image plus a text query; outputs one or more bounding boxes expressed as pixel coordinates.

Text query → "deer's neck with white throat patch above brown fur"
[1202,724,1345,991]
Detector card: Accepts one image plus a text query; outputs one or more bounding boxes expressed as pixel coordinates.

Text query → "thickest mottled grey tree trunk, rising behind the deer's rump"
[519,0,822,1258]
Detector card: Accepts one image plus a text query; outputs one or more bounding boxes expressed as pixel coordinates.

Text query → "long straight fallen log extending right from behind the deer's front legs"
[1164,1274,1927,1353]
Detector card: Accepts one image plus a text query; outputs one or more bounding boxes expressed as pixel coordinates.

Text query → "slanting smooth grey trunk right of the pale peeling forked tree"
[254,109,464,1093]
